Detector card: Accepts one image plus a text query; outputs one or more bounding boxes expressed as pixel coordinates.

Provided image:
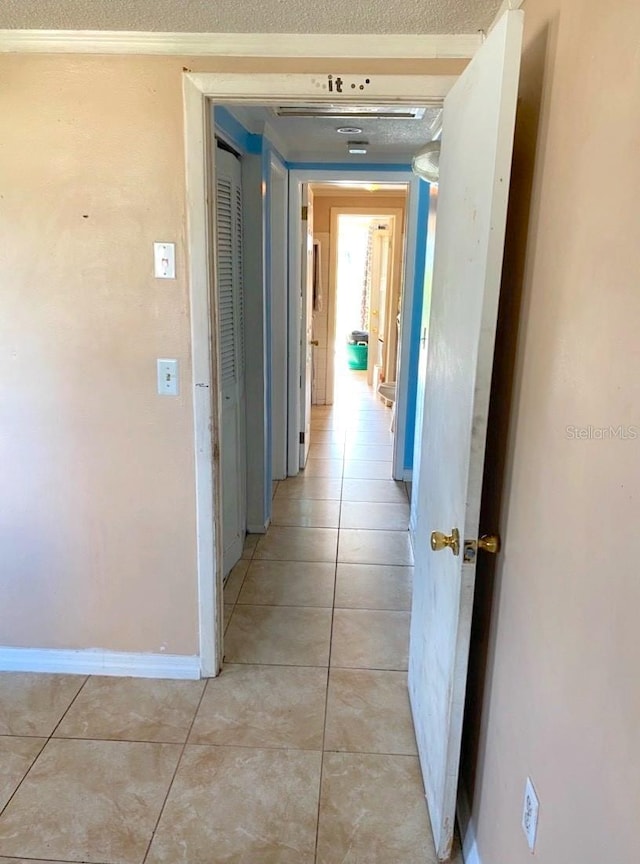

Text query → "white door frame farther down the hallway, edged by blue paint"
[289,165,422,480]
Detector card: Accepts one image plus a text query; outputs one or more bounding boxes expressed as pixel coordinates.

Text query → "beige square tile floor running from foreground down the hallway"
[0,375,461,864]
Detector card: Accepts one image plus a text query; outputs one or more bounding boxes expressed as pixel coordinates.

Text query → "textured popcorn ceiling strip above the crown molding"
[0,0,500,33]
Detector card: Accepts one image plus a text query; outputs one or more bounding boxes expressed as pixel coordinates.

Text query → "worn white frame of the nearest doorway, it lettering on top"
[183,71,456,677]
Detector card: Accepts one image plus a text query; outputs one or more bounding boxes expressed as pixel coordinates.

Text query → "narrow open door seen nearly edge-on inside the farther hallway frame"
[300,183,313,468]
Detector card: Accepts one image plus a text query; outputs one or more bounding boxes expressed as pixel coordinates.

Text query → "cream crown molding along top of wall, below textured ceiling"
[0,30,482,60]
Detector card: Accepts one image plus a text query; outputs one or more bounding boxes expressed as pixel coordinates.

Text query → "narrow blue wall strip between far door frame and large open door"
[404,180,429,471]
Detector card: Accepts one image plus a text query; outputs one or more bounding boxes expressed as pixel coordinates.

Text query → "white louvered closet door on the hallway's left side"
[216,147,246,576]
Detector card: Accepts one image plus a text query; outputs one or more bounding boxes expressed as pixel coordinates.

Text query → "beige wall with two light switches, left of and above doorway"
[0,54,442,654]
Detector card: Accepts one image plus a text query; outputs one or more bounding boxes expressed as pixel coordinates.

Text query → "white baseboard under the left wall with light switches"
[0,646,200,680]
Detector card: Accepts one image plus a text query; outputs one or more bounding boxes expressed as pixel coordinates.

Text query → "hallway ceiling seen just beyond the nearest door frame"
[226,106,442,164]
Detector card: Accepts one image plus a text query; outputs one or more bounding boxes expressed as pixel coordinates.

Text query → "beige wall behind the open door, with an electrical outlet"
[464,0,640,864]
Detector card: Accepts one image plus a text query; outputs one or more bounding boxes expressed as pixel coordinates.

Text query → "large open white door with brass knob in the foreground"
[409,10,523,860]
